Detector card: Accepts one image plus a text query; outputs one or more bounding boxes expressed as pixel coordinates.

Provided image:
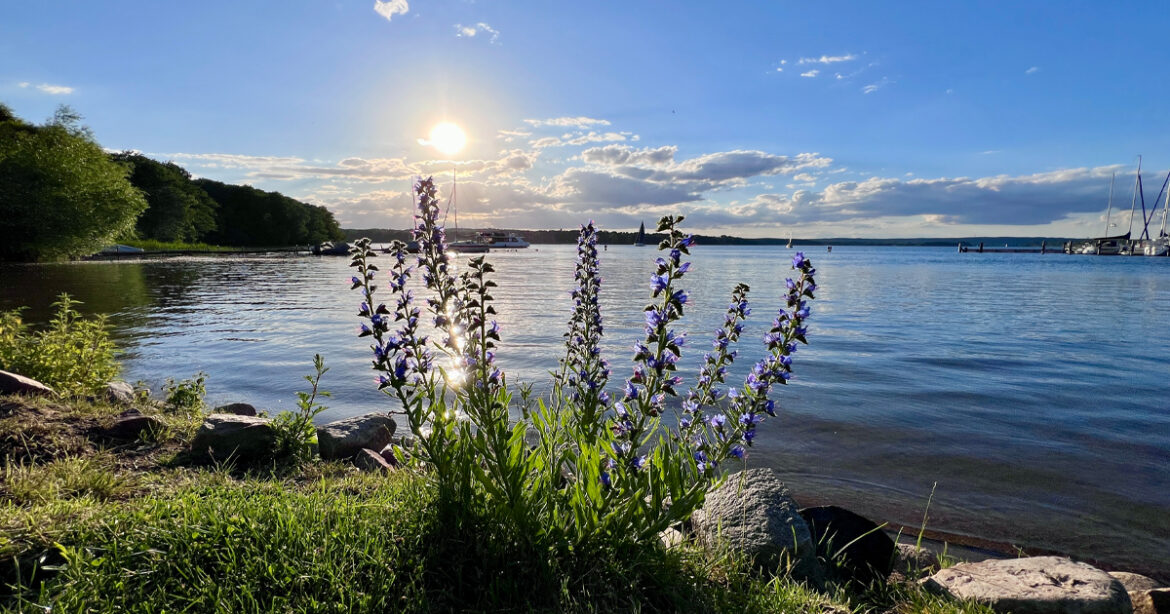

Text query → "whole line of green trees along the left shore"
[0,104,345,261]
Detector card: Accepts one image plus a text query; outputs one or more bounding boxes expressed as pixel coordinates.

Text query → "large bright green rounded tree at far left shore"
[0,105,146,261]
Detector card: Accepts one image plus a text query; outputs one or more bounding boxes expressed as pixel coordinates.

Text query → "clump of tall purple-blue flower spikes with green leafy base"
[351,173,815,547]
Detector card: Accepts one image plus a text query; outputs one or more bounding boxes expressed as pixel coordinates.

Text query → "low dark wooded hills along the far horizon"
[343,228,1076,247]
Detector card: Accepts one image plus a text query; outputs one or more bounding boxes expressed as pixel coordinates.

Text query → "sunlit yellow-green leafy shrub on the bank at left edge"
[0,294,121,396]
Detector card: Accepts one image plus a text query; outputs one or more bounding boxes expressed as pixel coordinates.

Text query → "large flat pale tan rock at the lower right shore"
[923,557,1133,614]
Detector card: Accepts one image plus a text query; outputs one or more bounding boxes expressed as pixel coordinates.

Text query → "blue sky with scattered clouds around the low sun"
[0,0,1170,237]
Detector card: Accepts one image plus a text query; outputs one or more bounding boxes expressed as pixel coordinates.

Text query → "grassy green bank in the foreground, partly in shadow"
[0,398,992,612]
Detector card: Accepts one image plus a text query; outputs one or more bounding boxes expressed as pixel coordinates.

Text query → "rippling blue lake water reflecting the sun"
[0,246,1170,573]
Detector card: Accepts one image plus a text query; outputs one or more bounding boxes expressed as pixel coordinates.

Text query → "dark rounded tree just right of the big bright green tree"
[110,151,219,242]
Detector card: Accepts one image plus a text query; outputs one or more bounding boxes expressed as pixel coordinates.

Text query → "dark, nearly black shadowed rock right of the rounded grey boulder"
[800,505,895,586]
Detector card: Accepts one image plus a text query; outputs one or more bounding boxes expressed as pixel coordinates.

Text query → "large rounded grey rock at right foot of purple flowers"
[691,469,824,584]
